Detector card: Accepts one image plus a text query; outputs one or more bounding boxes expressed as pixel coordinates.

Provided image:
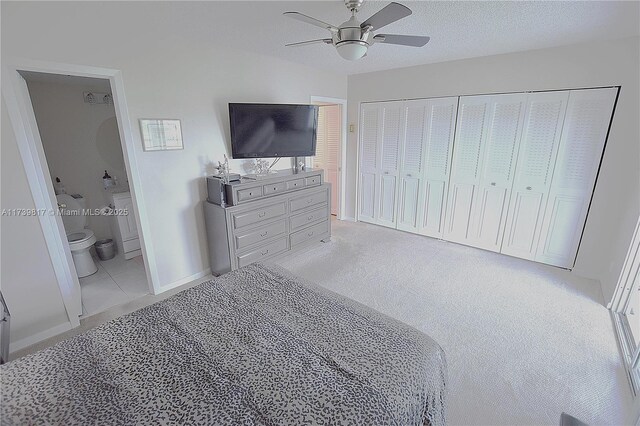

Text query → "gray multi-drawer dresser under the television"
[204,170,331,275]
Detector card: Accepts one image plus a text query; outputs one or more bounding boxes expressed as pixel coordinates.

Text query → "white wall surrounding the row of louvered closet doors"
[347,37,640,301]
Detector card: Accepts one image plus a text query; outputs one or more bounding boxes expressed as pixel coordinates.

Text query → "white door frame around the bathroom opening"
[2,58,161,330]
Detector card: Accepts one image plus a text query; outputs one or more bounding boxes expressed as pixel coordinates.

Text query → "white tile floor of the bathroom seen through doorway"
[80,255,149,317]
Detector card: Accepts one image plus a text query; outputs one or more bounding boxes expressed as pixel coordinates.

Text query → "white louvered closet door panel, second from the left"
[376,102,403,228]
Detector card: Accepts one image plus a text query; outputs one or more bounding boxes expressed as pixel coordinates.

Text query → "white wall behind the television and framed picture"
[0,2,347,344]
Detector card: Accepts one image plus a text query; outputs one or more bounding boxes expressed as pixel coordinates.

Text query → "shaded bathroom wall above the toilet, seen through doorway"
[26,77,126,239]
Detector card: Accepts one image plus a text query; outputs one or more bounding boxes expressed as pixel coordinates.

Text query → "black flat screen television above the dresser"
[229,103,318,158]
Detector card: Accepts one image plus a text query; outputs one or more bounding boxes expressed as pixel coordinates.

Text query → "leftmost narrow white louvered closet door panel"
[358,104,382,223]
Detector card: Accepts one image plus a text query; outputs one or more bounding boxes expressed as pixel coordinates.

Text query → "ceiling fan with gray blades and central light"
[284,0,429,61]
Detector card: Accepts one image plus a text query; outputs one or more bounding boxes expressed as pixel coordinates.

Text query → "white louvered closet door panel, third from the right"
[467,93,527,252]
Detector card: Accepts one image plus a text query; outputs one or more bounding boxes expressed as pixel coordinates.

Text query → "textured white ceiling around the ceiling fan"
[160,0,640,74]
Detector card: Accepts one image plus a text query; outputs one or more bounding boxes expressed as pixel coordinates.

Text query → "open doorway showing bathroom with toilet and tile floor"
[20,71,150,317]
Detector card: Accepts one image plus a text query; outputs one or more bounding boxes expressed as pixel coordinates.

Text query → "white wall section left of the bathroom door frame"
[0,99,69,349]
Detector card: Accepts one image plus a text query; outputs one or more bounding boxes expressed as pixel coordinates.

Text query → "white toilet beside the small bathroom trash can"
[56,194,98,278]
